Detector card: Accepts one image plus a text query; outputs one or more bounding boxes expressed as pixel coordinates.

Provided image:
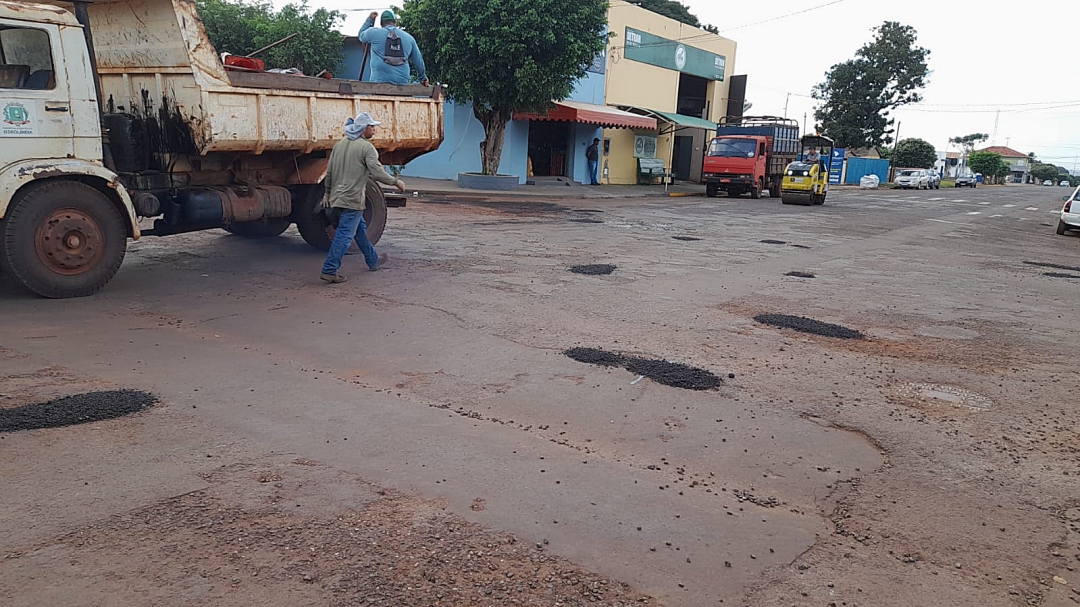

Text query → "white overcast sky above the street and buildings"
[300,0,1080,165]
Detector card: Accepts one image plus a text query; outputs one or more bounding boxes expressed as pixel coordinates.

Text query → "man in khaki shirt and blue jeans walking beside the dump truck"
[322,111,405,284]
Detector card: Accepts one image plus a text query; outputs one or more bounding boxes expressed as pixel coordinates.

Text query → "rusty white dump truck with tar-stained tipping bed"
[0,0,443,298]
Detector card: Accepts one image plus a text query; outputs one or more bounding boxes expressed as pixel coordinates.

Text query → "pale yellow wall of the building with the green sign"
[604,0,735,184]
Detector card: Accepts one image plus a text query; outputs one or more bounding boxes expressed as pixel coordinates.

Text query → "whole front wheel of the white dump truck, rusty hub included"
[0,180,127,299]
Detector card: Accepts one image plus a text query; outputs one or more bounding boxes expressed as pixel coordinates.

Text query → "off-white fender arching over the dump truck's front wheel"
[0,159,140,240]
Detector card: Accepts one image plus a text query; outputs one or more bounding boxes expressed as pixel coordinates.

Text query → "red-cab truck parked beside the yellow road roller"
[701,116,799,199]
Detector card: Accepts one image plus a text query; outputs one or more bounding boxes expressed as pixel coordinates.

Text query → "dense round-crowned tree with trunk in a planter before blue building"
[402,0,608,175]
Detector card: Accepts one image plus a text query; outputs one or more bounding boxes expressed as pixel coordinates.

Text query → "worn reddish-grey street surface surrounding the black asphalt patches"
[0,186,1080,607]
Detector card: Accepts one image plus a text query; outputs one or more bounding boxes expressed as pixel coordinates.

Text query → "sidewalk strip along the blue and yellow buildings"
[402,177,705,200]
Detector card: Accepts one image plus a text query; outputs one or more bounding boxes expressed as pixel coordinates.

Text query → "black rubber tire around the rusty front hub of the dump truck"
[0,179,127,299]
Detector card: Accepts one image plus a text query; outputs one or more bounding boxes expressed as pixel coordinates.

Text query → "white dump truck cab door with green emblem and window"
[0,19,75,166]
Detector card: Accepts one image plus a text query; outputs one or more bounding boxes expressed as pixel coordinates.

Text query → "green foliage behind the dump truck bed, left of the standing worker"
[195,0,343,76]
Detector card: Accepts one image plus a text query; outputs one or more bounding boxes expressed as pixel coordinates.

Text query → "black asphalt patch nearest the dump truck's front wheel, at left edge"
[0,390,158,432]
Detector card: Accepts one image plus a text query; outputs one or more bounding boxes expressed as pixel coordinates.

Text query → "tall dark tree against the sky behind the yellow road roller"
[813,22,930,148]
